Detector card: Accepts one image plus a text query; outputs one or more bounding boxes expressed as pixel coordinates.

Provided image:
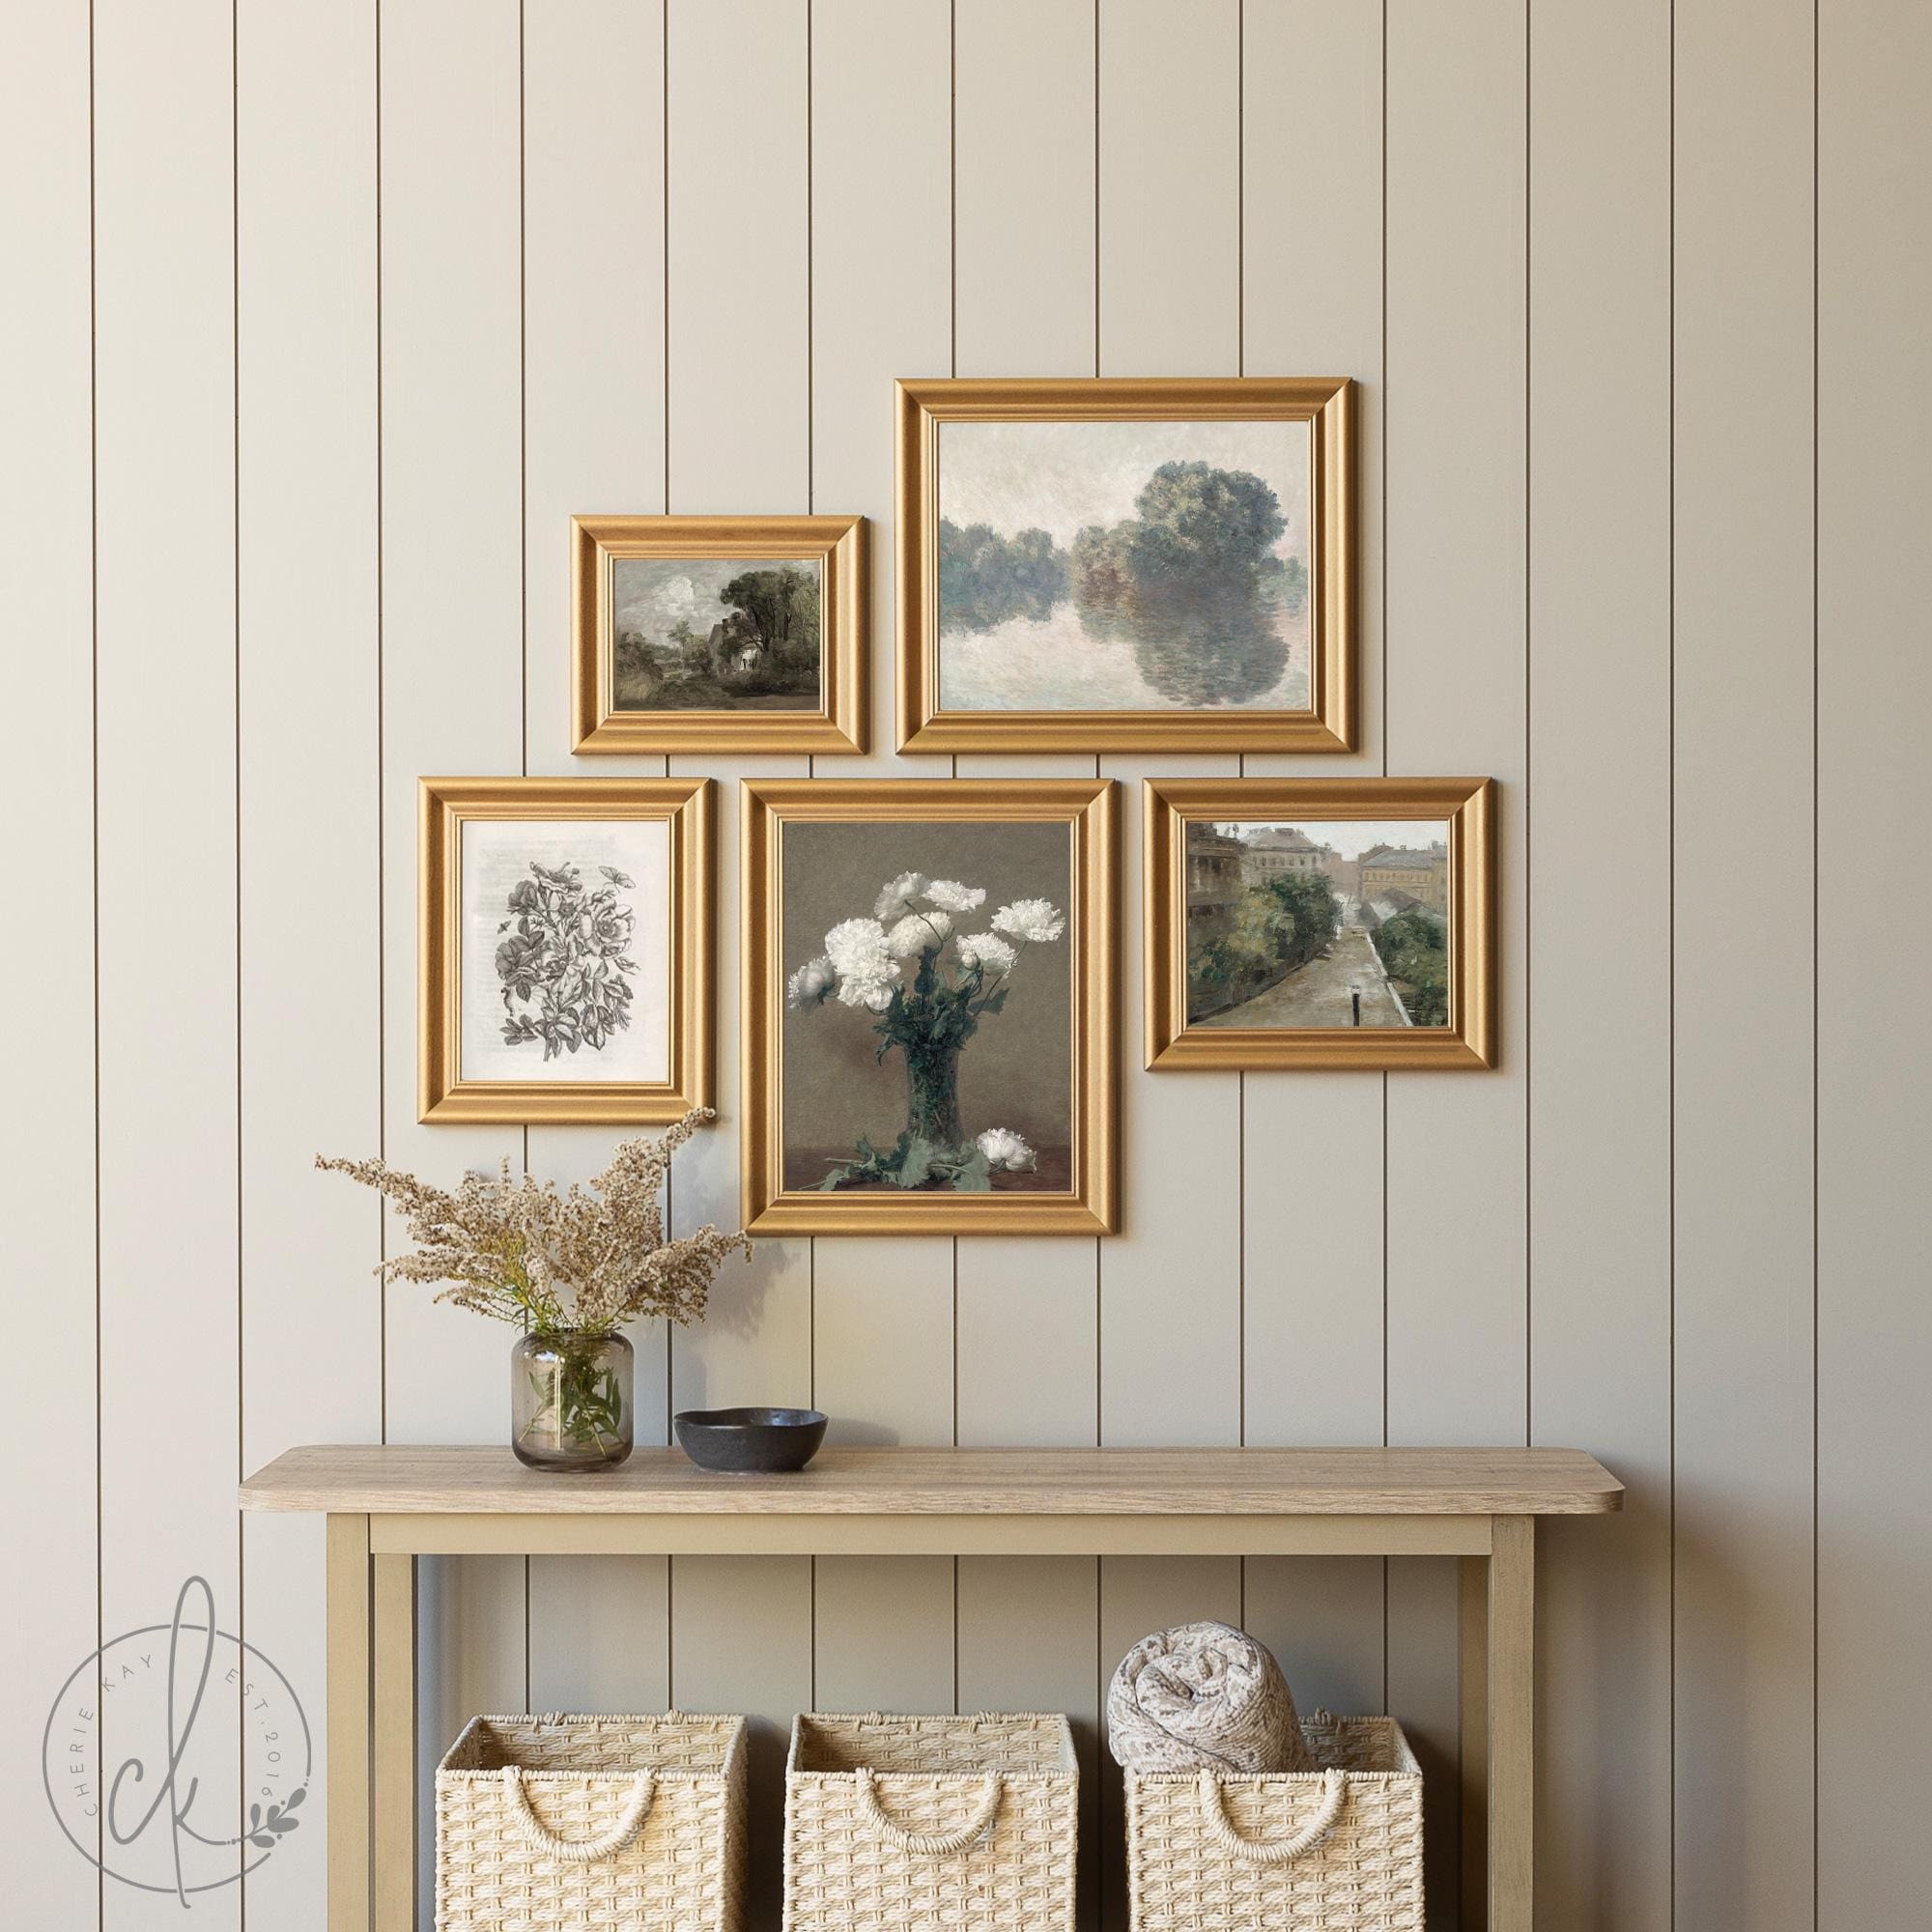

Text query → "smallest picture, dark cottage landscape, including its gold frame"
[570,516,869,753]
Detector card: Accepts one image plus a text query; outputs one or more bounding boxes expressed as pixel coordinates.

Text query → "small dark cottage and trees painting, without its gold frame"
[611,556,821,711]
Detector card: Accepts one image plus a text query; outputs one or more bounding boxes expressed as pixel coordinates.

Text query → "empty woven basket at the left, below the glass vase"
[437,1712,746,1932]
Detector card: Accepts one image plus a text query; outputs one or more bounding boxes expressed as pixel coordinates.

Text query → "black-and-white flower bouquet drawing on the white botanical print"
[497,860,638,1061]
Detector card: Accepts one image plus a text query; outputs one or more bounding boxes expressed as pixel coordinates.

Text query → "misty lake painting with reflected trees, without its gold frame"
[937,421,1310,711]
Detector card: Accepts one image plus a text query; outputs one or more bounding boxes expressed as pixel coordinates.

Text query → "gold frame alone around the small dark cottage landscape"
[570,516,871,755]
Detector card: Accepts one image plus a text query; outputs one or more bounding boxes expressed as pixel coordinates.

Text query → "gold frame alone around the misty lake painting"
[895,377,1356,752]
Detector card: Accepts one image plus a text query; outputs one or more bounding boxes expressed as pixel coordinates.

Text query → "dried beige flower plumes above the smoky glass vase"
[315,1107,752,1335]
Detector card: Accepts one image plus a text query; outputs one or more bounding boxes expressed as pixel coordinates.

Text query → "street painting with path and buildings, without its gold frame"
[1186,819,1449,1028]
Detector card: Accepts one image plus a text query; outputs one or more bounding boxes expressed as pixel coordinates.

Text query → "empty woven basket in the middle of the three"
[784,1716,1080,1932]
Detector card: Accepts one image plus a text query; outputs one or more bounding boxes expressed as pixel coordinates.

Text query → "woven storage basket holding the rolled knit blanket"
[1126,1712,1422,1932]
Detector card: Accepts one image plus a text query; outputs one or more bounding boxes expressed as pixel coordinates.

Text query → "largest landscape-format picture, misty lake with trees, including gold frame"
[896,377,1356,752]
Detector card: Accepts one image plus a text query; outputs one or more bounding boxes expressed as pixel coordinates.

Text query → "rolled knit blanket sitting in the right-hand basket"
[1107,1623,1318,1772]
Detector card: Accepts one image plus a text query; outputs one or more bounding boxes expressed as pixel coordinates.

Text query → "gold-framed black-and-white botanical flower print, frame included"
[417,779,713,1124]
